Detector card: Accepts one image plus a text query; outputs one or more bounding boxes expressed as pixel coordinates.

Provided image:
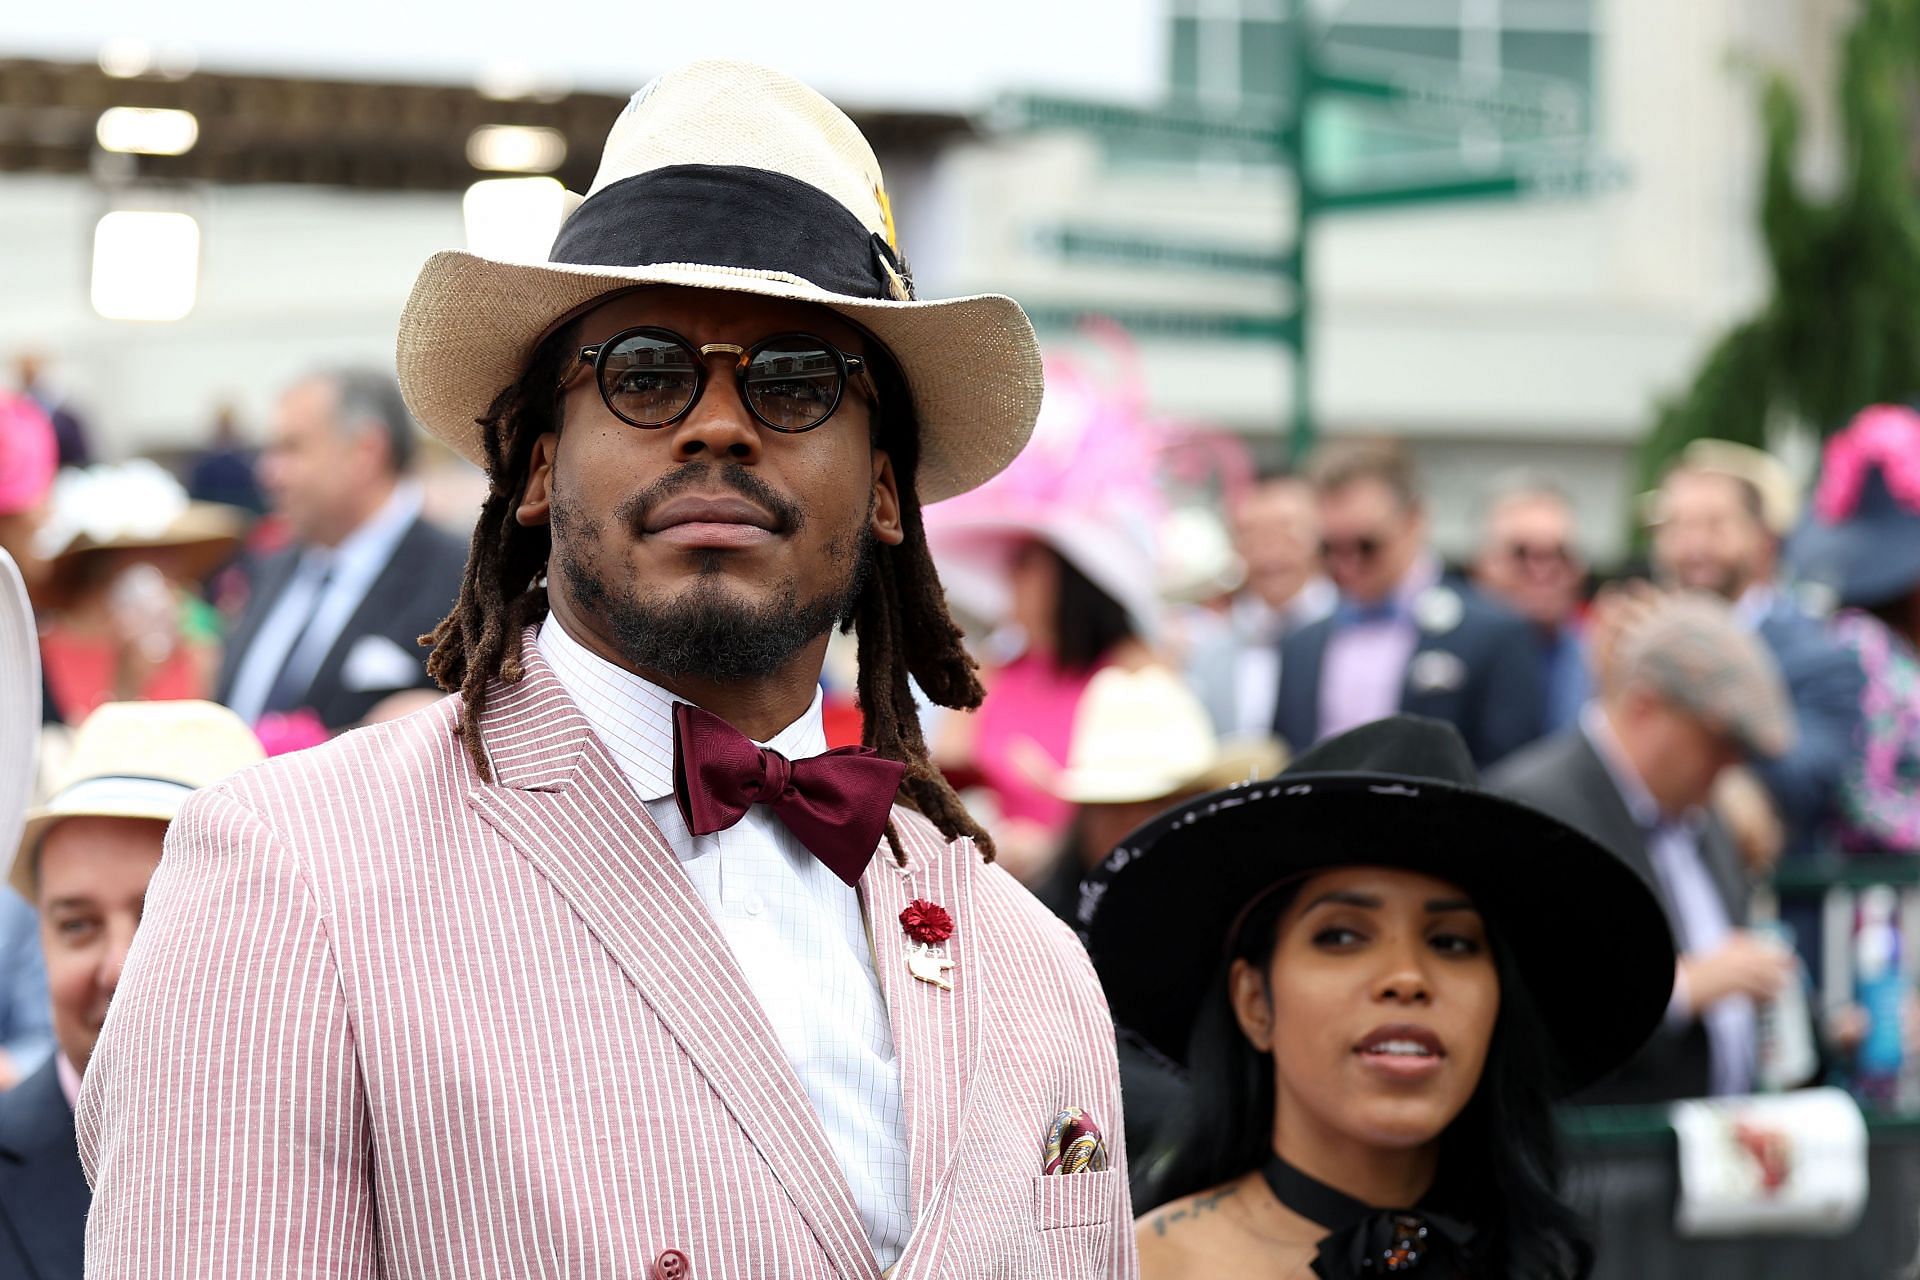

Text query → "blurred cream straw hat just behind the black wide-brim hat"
[1048,666,1286,804]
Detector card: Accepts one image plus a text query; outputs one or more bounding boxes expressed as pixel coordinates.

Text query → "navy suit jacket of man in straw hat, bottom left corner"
[0,1059,92,1280]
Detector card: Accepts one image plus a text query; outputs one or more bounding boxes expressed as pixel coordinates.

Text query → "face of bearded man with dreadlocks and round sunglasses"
[518,288,902,677]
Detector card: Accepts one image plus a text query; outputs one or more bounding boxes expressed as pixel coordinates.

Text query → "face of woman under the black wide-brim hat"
[1231,867,1500,1167]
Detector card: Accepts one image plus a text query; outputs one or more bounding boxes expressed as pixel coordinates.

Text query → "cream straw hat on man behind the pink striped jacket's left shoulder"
[8,700,267,898]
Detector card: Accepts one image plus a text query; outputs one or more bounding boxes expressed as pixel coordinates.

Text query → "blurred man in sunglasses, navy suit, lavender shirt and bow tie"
[1273,441,1544,766]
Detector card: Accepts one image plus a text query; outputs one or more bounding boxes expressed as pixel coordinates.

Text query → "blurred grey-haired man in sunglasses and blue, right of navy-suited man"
[1473,470,1592,733]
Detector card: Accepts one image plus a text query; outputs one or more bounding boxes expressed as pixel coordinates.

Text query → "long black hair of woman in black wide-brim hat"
[1135,881,1594,1280]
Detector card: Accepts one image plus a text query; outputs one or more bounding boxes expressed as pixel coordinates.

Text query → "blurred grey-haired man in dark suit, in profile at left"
[217,370,467,729]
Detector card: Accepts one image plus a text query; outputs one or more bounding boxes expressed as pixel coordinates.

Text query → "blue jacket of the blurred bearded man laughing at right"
[1753,595,1864,856]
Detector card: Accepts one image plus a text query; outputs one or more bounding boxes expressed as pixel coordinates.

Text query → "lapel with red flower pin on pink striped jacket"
[860,810,991,1251]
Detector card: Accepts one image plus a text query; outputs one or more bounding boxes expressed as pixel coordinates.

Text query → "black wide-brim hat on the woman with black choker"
[1079,716,1674,1092]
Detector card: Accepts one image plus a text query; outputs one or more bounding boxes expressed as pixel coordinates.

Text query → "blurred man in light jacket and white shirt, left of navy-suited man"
[1187,474,1338,737]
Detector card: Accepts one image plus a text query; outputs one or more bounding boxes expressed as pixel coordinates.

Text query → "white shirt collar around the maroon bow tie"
[536,618,828,800]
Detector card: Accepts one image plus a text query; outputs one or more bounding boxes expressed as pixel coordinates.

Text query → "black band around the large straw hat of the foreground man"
[547,165,914,301]
